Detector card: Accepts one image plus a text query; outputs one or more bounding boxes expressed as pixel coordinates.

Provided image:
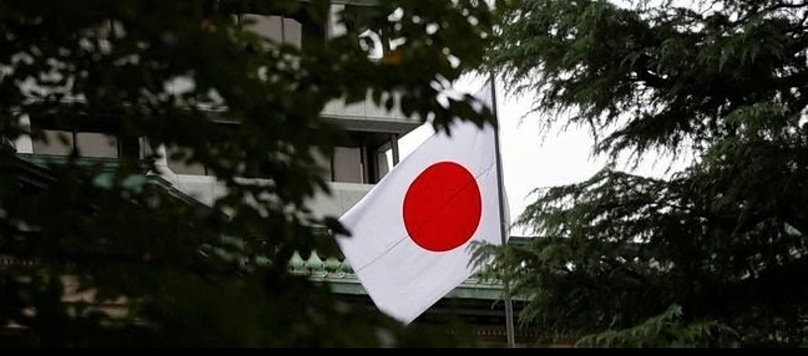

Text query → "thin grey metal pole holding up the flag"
[488,72,516,348]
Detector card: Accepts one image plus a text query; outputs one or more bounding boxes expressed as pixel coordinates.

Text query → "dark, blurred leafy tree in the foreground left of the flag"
[0,0,491,347]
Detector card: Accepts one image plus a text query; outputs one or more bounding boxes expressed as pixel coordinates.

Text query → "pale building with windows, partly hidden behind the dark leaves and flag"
[7,1,535,346]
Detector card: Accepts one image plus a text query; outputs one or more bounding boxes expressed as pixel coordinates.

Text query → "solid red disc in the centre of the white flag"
[403,162,482,252]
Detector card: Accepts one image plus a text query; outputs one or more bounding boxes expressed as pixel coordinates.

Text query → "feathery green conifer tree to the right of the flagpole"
[479,0,808,347]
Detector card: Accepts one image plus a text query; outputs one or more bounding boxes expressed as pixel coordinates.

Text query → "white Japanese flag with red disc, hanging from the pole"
[336,84,509,324]
